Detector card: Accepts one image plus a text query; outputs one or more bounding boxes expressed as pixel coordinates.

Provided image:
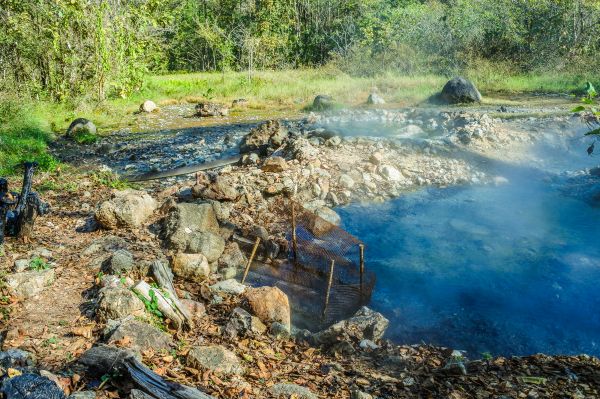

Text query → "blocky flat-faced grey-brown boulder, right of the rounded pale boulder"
[163,203,220,250]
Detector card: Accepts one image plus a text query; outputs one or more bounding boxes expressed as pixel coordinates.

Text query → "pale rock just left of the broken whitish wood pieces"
[96,287,146,322]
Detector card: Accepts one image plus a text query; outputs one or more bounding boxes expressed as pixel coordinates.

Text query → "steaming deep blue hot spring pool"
[338,155,600,358]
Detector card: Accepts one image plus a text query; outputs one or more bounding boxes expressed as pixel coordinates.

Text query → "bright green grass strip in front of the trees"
[0,68,600,175]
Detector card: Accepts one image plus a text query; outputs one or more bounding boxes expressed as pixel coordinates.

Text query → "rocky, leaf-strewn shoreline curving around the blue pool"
[0,111,600,399]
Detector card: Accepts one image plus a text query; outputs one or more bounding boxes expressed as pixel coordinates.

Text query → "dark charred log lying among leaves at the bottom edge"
[74,344,215,399]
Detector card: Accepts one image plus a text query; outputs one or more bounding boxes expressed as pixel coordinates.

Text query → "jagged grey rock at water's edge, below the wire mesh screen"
[313,306,390,345]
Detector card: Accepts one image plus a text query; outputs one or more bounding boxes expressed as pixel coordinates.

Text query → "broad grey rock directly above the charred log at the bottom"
[105,317,173,352]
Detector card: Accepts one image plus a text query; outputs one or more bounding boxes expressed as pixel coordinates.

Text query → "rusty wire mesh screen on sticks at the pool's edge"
[286,200,375,327]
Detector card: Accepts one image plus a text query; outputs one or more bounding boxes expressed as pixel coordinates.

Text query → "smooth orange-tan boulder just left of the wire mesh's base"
[244,287,292,329]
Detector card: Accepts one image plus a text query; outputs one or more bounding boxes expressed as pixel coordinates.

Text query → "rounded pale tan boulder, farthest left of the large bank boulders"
[96,190,158,230]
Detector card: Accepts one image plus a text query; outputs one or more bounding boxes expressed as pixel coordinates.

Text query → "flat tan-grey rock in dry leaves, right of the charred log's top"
[186,345,244,375]
